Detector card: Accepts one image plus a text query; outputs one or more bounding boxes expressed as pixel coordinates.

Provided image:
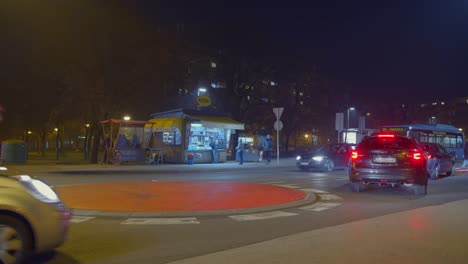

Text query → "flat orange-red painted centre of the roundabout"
[55,182,306,212]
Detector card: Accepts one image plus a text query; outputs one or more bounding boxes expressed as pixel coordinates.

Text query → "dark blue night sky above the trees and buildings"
[138,0,468,99]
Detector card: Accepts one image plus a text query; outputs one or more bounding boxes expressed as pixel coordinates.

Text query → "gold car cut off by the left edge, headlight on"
[0,167,71,264]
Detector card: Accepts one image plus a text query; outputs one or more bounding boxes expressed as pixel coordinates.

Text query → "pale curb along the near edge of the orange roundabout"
[70,193,318,218]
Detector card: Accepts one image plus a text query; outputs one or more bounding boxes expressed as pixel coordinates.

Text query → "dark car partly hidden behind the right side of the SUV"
[419,143,455,180]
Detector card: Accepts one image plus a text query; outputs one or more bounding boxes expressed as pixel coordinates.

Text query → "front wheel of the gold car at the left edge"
[0,215,33,264]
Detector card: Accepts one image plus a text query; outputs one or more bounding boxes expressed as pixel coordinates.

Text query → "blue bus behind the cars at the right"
[380,124,465,160]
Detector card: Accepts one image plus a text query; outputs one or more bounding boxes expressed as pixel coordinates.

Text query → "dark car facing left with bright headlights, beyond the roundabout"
[296,143,356,171]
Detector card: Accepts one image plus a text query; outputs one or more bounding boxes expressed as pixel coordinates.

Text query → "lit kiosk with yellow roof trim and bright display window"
[150,109,244,163]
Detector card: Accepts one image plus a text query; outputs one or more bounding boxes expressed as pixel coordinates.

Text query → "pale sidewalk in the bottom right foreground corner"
[171,200,468,264]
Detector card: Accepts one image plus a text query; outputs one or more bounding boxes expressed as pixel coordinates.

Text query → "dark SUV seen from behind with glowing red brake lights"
[349,132,427,195]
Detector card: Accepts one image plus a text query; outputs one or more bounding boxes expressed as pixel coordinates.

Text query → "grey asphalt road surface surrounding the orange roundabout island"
[25,166,468,263]
